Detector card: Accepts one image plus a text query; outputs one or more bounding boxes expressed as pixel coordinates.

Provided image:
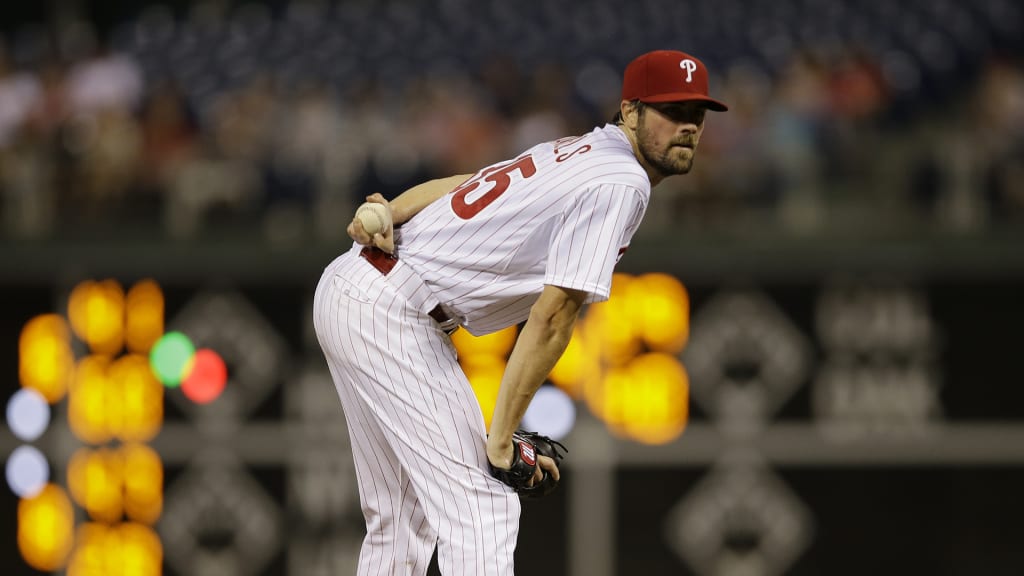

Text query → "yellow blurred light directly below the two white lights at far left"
[17,484,75,572]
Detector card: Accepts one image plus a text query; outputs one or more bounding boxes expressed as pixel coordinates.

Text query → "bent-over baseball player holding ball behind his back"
[313,50,727,576]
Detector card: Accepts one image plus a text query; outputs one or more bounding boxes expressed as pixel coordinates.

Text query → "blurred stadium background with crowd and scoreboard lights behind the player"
[0,0,1024,576]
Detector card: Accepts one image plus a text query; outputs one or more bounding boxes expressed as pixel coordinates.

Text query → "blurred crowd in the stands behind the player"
[0,1,1024,242]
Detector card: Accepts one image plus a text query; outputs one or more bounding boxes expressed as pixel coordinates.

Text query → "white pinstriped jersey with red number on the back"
[396,124,650,335]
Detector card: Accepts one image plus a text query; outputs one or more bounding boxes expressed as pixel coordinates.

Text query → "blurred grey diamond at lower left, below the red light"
[160,455,282,576]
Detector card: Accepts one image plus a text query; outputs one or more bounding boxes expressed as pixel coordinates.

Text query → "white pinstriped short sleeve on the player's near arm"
[544,184,647,302]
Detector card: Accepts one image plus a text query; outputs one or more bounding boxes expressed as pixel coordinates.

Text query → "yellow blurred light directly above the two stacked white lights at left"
[17,314,75,404]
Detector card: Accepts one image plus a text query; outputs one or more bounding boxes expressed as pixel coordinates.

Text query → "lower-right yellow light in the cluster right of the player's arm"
[605,354,689,444]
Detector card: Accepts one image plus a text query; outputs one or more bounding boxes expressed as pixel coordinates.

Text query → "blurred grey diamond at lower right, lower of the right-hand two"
[665,457,813,576]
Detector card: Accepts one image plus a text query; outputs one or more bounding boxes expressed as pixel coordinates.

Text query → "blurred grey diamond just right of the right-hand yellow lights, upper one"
[683,291,811,426]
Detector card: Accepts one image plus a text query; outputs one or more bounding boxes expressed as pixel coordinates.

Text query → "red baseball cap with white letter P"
[623,50,729,112]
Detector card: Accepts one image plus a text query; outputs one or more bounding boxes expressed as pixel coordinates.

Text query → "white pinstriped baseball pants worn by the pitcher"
[313,251,520,576]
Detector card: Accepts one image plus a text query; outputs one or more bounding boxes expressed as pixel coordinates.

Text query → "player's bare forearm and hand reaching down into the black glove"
[487,285,587,481]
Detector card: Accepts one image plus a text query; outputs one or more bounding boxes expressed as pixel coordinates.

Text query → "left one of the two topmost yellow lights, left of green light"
[68,280,125,354]
